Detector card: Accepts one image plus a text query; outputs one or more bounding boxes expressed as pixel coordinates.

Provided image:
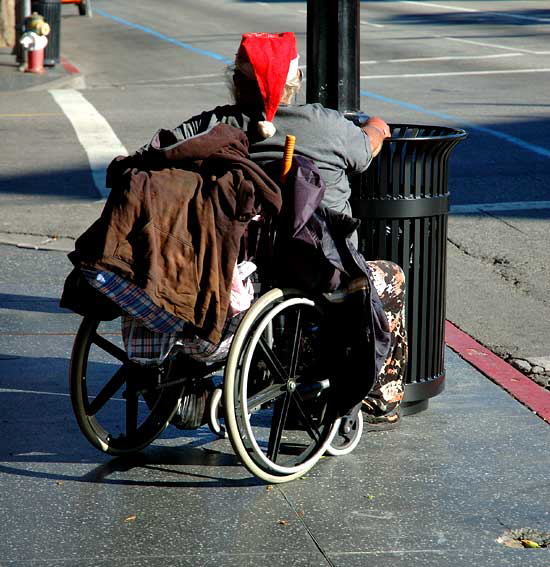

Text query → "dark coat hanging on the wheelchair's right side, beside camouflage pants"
[273,156,390,415]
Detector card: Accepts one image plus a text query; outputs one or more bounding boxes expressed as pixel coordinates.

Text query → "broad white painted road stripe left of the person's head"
[50,89,128,198]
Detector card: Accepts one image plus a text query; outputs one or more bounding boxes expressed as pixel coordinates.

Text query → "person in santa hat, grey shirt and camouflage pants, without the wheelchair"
[116,32,407,430]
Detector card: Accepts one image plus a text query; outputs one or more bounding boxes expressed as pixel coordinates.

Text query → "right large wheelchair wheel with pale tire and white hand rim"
[224,288,340,483]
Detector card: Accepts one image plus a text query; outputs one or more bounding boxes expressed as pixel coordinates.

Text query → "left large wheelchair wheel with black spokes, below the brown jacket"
[69,317,183,455]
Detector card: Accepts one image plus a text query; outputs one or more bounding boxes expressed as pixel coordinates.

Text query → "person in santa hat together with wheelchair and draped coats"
[61,33,407,482]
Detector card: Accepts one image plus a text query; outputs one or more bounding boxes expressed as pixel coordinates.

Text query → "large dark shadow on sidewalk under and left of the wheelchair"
[0,355,262,487]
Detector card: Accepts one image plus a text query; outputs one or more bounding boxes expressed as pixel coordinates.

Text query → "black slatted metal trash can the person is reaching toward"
[351,124,467,414]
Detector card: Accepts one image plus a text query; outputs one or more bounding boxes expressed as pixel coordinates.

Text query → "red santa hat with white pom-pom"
[236,32,298,138]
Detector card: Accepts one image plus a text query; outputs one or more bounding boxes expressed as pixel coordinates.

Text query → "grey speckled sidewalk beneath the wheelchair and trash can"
[0,245,550,567]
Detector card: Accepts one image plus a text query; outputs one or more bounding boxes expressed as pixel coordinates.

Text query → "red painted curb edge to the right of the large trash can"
[445,321,550,423]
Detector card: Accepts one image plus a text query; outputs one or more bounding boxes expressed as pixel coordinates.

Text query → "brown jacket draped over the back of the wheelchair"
[62,124,281,343]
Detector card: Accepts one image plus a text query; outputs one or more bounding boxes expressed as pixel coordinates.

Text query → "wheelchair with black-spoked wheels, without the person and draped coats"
[69,140,363,483]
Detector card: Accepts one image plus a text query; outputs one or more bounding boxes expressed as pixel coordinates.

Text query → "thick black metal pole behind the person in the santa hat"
[306,0,359,112]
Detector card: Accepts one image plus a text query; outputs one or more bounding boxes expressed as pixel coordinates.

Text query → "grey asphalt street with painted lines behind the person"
[0,0,550,383]
